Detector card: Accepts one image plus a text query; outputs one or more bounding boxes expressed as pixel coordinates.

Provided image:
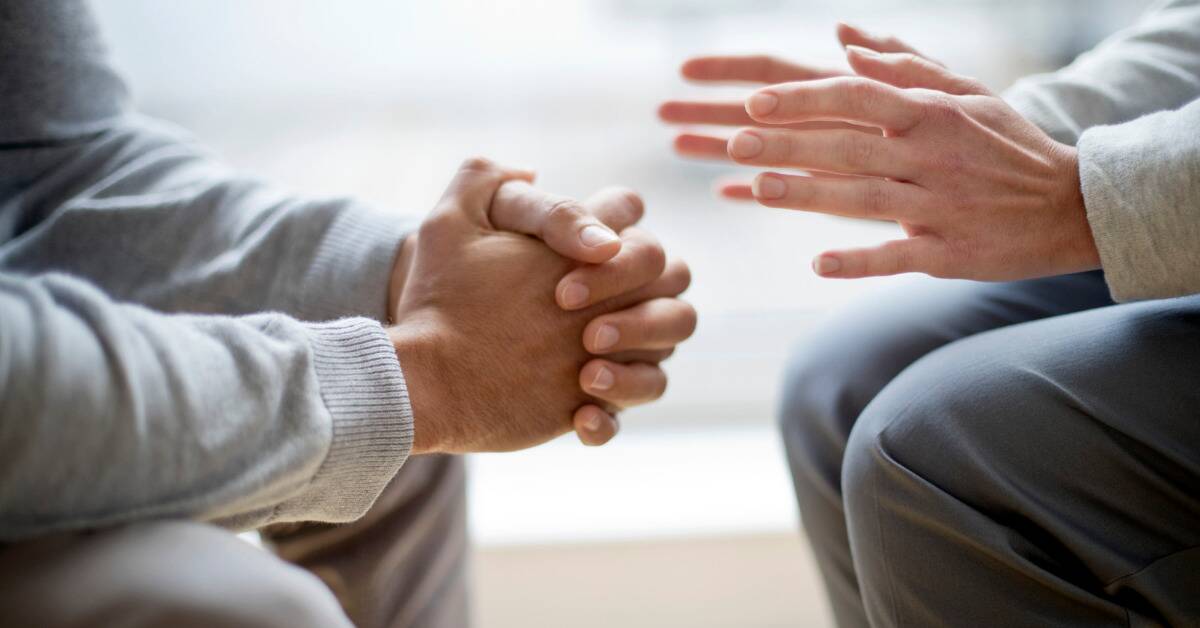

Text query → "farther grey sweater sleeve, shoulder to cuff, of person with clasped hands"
[0,0,413,321]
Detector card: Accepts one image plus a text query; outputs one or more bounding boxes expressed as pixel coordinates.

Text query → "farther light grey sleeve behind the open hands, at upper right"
[1004,0,1200,145]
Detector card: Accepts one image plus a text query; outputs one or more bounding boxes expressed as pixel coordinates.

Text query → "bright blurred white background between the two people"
[96,0,1148,628]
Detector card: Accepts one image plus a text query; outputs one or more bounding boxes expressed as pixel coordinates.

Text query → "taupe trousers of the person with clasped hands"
[0,456,469,628]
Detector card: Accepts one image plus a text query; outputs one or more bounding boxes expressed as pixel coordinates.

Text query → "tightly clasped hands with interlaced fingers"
[389,159,696,454]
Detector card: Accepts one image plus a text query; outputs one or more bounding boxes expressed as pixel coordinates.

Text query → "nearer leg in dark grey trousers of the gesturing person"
[842,297,1200,626]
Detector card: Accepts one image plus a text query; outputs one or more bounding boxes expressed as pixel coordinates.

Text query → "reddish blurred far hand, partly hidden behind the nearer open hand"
[659,24,936,201]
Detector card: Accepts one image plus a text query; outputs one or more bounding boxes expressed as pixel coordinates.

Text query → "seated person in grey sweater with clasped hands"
[0,0,695,628]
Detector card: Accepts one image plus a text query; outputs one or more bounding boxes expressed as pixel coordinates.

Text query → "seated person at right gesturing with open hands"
[661,6,1200,627]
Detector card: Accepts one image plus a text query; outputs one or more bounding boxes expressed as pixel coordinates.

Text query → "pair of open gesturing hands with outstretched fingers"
[660,26,1099,281]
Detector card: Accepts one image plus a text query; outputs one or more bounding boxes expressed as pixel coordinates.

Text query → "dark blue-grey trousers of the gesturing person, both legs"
[781,273,1200,627]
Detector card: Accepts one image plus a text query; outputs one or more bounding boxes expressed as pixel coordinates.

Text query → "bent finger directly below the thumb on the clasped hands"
[554,227,666,310]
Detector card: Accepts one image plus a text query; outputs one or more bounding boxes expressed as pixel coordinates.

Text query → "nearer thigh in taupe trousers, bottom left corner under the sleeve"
[0,521,350,628]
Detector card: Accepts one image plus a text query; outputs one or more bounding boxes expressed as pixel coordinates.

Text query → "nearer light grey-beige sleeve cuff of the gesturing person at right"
[1079,100,1200,301]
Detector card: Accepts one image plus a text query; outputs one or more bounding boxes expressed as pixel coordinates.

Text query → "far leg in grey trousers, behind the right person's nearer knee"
[780,273,1112,626]
